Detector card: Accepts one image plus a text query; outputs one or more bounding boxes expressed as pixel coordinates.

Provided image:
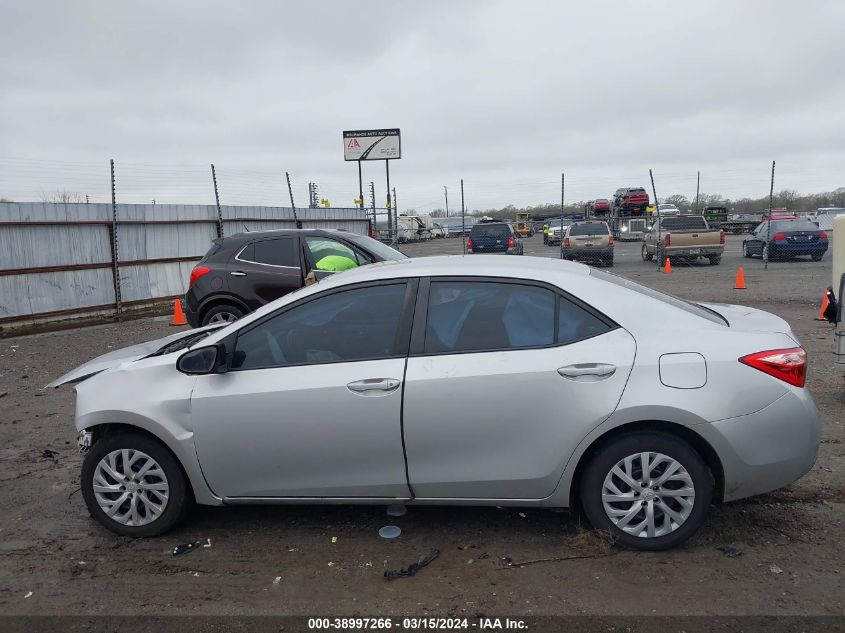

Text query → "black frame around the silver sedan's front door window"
[226,277,419,372]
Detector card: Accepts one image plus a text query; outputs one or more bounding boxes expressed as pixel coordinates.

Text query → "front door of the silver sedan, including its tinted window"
[191,280,415,498]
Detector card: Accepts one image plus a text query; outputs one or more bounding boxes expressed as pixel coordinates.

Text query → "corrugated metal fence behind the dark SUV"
[0,202,368,331]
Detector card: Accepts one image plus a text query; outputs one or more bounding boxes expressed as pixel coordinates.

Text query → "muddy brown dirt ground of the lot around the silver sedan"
[0,238,845,616]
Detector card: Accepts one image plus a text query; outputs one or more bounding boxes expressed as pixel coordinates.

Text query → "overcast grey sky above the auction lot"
[0,0,845,210]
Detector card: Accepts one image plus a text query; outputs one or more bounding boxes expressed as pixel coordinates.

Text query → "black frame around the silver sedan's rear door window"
[409,275,622,358]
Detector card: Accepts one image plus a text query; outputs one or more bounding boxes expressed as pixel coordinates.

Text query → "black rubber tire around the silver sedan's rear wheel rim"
[579,431,713,551]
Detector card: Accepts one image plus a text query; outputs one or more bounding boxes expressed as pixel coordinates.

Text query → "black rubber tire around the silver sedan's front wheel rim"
[81,433,193,538]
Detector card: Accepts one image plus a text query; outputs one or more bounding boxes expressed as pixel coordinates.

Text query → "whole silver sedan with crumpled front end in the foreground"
[53,255,820,550]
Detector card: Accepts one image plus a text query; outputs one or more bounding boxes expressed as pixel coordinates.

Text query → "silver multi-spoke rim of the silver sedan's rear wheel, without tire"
[602,452,695,538]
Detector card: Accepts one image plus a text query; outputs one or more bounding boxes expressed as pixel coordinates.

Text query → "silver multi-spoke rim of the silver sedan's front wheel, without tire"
[93,448,170,526]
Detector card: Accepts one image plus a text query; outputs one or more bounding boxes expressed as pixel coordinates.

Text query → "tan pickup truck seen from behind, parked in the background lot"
[642,215,725,266]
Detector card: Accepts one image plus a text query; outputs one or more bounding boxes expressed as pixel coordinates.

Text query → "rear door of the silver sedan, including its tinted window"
[403,280,636,499]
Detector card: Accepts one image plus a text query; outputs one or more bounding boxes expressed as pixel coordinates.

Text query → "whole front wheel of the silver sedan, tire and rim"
[81,433,191,537]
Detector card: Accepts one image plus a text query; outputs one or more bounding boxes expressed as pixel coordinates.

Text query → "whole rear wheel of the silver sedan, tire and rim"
[580,432,713,550]
